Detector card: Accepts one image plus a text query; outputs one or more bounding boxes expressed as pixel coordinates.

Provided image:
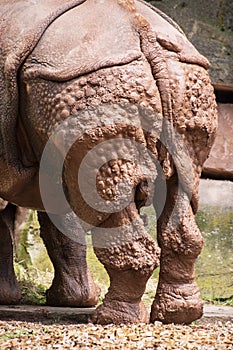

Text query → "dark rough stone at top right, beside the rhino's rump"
[148,0,233,90]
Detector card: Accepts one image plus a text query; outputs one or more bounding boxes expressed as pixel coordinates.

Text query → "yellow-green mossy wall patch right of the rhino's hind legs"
[196,207,233,305]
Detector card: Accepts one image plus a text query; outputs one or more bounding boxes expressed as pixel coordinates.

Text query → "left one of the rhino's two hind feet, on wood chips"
[91,300,149,325]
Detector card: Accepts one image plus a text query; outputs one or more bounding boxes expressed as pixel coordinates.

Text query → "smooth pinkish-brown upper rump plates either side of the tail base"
[20,0,208,81]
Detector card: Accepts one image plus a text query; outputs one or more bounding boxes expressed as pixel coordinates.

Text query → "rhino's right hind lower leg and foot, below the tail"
[151,174,203,324]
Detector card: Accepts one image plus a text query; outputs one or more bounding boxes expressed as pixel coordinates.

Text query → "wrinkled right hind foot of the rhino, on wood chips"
[150,282,203,324]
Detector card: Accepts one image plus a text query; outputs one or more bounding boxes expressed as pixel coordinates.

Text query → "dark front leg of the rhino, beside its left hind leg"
[38,212,100,307]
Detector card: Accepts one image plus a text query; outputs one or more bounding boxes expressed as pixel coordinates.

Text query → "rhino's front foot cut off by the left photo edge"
[0,278,21,305]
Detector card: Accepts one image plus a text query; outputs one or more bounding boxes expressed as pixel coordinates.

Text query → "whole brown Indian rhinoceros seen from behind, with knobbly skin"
[0,0,217,324]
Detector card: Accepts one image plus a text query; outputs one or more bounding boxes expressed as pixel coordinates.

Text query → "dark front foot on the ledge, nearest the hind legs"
[46,271,100,307]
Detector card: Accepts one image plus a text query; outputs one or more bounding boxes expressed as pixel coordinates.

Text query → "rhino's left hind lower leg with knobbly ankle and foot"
[92,203,159,324]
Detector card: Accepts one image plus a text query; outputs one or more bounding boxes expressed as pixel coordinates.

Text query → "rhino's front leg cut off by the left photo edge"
[0,200,21,304]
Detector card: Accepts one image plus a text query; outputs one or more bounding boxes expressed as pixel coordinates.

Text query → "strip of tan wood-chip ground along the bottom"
[0,321,233,350]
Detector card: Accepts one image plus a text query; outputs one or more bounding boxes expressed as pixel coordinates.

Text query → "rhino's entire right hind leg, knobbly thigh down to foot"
[150,60,216,323]
